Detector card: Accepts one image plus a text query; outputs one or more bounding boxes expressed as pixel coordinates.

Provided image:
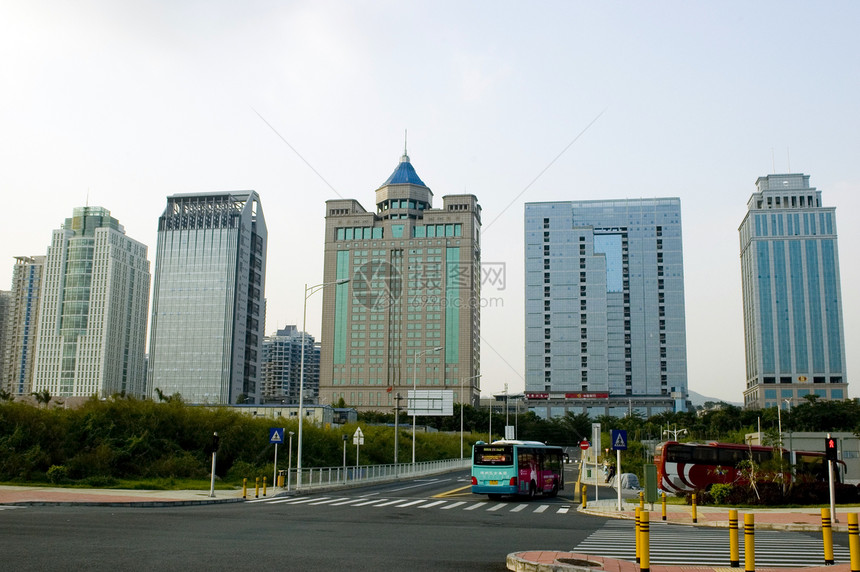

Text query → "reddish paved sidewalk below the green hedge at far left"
[0,486,254,507]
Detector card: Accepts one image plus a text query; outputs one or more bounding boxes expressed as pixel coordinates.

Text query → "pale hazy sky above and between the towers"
[0,0,860,402]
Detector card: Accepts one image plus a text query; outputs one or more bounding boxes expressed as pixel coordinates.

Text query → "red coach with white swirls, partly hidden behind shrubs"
[654,441,845,493]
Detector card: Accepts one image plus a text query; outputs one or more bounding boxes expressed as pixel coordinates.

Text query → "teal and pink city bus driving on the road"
[472,440,564,500]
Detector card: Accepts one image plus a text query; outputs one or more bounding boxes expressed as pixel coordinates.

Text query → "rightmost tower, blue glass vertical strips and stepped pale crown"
[739,174,848,408]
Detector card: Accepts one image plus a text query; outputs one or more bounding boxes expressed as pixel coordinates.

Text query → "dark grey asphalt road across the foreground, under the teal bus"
[0,471,605,571]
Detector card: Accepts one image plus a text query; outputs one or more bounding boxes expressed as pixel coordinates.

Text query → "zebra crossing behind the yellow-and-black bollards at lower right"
[573,520,851,567]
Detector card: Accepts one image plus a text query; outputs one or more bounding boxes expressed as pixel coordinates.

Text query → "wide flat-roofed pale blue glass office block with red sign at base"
[525,198,687,417]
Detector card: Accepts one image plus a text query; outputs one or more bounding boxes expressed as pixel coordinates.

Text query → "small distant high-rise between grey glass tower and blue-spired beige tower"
[263,326,320,405]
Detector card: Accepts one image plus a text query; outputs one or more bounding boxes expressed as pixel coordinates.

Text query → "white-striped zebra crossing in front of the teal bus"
[247,497,571,514]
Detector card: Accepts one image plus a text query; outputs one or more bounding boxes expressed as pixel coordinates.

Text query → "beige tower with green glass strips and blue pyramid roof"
[320,152,481,411]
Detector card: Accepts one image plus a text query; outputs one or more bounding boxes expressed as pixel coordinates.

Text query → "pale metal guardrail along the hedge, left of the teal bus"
[286,459,471,490]
